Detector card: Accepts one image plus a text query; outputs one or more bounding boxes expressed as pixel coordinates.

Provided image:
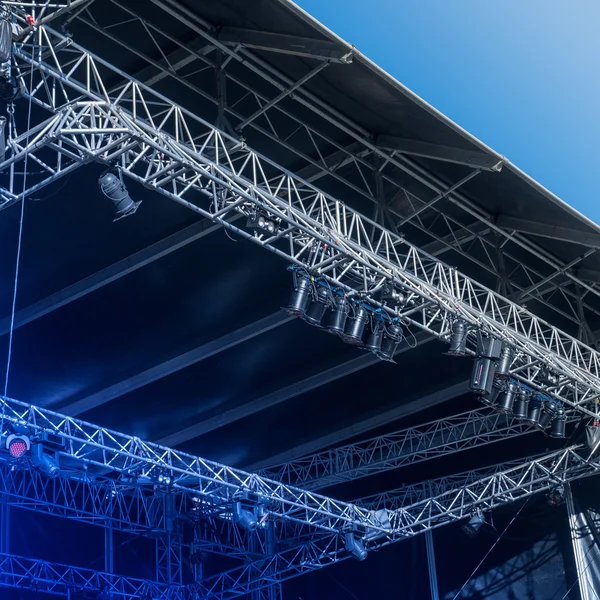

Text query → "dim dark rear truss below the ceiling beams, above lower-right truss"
[260,408,534,490]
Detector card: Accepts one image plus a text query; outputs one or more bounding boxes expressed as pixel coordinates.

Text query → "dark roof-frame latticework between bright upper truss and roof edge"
[70,0,600,338]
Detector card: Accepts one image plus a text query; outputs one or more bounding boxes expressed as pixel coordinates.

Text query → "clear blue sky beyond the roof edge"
[297,0,600,223]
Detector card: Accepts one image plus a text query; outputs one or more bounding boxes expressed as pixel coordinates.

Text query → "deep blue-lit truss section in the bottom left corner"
[0,554,178,600]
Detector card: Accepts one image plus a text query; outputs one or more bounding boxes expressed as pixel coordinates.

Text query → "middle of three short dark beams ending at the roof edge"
[375,135,502,171]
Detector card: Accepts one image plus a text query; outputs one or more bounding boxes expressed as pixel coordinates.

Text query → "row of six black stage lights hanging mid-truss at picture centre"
[283,272,404,362]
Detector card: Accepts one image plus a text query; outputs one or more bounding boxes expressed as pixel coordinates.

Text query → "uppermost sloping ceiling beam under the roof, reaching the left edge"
[0,217,230,335]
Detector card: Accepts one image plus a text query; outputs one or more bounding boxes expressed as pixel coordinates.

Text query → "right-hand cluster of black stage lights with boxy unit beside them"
[447,320,567,438]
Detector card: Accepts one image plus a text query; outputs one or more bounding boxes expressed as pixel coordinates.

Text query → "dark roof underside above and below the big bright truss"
[0,0,600,592]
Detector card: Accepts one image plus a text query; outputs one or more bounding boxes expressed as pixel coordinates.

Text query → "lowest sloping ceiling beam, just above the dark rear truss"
[246,381,469,471]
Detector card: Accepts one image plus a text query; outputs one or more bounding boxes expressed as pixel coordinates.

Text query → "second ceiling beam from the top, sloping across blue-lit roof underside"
[61,311,294,416]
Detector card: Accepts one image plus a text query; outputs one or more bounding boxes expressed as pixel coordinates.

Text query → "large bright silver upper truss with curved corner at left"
[0,27,600,416]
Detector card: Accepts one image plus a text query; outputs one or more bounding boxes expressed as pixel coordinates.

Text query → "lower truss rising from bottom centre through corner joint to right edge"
[193,447,600,600]
